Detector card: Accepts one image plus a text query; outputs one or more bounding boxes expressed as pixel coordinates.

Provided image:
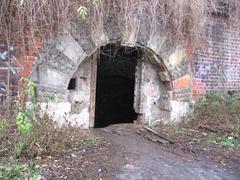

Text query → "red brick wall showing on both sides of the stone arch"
[0,17,240,107]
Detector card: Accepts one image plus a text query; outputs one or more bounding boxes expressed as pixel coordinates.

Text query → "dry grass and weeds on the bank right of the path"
[156,92,240,172]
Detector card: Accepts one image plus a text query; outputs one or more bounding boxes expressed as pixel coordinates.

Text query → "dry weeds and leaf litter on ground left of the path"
[0,115,108,179]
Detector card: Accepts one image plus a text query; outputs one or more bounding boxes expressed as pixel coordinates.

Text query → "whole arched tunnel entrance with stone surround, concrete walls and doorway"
[30,34,192,128]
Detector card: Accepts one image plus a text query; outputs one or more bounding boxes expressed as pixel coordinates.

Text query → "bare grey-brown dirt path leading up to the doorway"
[94,124,240,180]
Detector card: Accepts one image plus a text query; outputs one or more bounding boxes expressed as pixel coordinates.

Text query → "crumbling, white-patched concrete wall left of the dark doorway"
[41,58,95,128]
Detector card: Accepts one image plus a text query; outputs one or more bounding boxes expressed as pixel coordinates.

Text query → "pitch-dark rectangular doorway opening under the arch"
[95,44,141,128]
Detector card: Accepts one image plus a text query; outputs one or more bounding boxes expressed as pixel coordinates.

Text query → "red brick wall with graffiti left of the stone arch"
[0,33,42,114]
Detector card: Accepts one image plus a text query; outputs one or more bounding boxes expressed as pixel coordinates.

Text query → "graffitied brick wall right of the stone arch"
[191,17,240,96]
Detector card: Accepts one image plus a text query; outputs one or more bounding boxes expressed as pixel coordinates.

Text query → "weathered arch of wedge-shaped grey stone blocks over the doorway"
[31,19,191,127]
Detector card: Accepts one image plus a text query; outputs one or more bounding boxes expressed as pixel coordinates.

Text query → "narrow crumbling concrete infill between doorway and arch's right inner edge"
[141,62,171,125]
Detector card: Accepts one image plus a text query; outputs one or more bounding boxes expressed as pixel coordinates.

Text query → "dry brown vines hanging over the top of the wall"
[0,0,240,44]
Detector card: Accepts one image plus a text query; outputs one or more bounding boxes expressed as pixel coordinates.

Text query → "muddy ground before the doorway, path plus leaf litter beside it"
[38,124,240,180]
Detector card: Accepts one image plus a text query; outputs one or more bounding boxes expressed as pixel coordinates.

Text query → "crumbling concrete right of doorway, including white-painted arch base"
[137,54,192,126]
